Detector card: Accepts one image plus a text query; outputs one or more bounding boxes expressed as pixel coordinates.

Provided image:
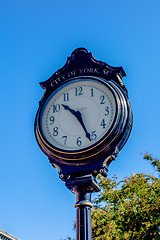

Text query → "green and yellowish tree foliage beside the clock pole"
[92,154,160,240]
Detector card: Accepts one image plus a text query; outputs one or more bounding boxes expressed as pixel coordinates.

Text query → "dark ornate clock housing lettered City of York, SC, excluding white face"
[35,48,133,180]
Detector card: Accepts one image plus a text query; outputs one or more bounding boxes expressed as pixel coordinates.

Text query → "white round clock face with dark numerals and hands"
[40,77,117,151]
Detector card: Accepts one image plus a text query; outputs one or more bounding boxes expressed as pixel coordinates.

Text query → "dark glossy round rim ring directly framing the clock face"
[35,76,126,165]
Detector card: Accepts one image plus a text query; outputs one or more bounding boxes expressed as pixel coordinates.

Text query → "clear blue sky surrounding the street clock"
[0,0,160,240]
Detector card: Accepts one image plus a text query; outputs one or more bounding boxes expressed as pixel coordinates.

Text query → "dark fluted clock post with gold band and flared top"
[66,174,101,240]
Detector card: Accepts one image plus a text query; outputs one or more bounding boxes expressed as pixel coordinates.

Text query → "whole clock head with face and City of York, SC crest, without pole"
[35,48,132,180]
